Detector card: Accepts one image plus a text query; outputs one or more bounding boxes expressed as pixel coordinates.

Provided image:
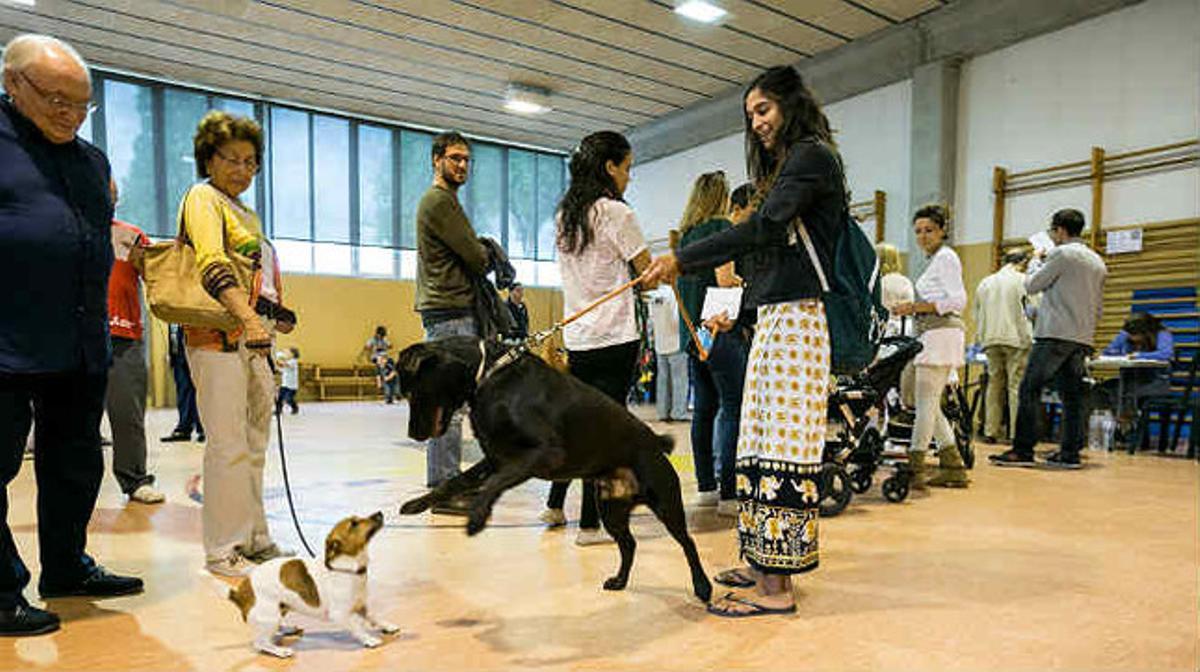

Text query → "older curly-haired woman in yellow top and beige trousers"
[179,112,295,576]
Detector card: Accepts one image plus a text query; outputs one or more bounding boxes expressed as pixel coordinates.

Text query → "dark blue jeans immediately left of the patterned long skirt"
[688,330,750,499]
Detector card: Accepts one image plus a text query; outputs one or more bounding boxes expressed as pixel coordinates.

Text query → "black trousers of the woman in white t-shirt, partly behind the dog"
[546,341,638,529]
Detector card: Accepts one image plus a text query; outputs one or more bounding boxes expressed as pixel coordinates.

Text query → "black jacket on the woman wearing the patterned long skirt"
[677,139,846,308]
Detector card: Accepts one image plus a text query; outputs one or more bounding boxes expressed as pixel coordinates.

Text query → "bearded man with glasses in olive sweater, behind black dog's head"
[416,131,487,515]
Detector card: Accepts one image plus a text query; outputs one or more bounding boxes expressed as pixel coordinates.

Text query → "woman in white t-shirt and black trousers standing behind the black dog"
[541,131,650,546]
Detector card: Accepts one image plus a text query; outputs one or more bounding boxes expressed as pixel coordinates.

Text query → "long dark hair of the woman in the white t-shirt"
[558,131,630,254]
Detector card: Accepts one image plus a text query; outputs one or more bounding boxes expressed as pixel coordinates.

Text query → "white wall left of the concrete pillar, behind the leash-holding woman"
[625,80,912,247]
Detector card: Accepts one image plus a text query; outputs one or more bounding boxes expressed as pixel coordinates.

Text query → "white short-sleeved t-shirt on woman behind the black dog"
[558,198,646,350]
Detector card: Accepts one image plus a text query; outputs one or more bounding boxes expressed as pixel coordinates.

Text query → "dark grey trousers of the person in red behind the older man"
[104,338,154,494]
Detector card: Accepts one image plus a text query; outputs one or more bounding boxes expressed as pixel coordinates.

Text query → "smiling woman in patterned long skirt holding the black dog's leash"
[643,67,847,618]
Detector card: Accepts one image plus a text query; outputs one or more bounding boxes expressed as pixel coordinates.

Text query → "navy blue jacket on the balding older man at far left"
[0,97,113,376]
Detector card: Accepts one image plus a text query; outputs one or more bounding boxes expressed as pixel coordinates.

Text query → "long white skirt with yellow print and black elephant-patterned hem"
[737,300,829,574]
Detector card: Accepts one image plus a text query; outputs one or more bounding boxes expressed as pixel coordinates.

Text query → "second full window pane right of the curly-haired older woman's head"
[312,115,350,243]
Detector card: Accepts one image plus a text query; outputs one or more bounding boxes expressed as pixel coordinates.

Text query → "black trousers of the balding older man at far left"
[0,371,108,608]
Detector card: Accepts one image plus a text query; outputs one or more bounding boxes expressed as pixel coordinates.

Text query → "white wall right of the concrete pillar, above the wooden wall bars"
[955,0,1200,242]
